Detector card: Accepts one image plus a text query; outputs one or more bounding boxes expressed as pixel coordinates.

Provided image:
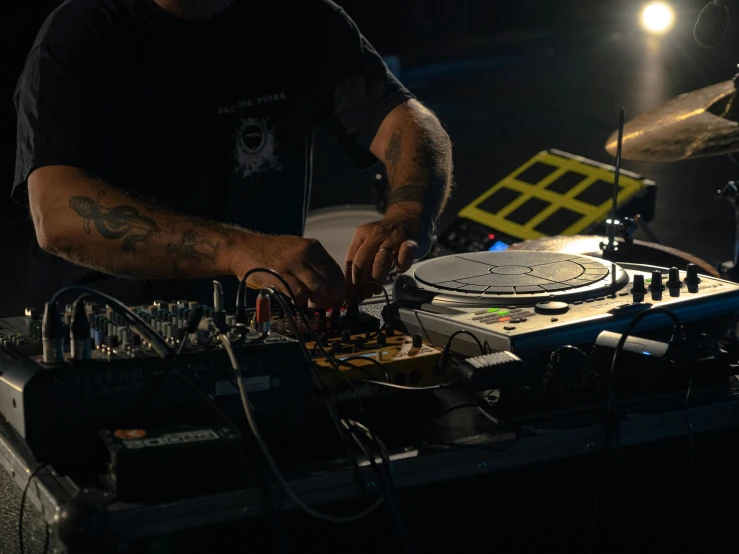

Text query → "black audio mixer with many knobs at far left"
[0,301,313,459]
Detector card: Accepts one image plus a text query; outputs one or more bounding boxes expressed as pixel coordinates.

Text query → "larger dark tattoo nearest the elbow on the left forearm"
[69,191,159,252]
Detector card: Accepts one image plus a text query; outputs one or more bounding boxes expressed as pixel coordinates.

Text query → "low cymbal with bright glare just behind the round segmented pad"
[509,235,719,277]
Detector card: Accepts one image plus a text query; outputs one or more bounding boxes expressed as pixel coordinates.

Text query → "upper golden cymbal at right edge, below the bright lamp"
[606,81,739,162]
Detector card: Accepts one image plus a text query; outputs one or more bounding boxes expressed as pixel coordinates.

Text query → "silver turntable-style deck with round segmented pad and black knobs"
[391,251,739,357]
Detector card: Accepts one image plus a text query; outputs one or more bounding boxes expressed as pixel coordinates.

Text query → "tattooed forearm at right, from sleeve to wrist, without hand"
[384,102,452,230]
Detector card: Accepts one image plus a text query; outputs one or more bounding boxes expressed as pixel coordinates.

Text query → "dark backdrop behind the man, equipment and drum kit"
[0,0,739,316]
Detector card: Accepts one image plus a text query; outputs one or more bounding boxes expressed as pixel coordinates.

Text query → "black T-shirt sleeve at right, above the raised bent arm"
[311,0,414,155]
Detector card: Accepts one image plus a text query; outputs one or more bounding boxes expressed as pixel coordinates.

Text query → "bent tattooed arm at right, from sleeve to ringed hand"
[345,100,452,300]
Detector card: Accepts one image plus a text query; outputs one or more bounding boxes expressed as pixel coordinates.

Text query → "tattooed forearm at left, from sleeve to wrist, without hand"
[29,168,248,278]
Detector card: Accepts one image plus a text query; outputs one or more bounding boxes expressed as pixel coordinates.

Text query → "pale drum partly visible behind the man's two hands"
[303,204,384,269]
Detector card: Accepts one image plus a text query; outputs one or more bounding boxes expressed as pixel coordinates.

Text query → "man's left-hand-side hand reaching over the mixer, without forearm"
[231,234,345,308]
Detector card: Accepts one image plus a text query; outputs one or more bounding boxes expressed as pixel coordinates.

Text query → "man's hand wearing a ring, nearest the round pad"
[344,214,428,304]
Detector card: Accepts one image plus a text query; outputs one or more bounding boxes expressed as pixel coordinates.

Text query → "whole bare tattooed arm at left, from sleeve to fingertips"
[28,166,344,307]
